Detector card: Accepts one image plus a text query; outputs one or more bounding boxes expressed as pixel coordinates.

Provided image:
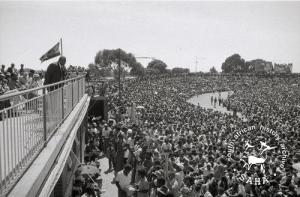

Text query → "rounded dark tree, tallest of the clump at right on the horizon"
[222,54,246,73]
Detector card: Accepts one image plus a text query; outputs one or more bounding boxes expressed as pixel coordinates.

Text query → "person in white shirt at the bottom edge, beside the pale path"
[115,164,132,197]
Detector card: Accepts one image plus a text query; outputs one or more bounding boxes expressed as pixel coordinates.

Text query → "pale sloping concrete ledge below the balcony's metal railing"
[8,94,90,197]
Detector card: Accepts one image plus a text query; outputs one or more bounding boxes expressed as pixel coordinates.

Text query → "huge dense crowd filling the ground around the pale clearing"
[80,75,300,197]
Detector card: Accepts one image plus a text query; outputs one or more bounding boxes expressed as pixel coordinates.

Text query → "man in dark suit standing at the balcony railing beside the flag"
[44,56,66,91]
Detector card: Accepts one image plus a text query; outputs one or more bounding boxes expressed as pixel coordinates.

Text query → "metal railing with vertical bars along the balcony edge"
[0,76,85,196]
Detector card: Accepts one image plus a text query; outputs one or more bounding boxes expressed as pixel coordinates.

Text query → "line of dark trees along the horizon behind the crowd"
[88,49,286,77]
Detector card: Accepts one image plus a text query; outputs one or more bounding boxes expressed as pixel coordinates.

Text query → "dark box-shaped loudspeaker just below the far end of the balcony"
[89,96,108,120]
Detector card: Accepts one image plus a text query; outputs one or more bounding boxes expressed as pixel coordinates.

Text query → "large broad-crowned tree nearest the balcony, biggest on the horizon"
[95,49,145,75]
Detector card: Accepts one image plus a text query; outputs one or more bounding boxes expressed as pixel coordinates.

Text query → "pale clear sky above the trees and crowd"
[0,1,300,72]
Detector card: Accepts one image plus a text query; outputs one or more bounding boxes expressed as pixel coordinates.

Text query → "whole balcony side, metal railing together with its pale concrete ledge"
[0,77,90,197]
